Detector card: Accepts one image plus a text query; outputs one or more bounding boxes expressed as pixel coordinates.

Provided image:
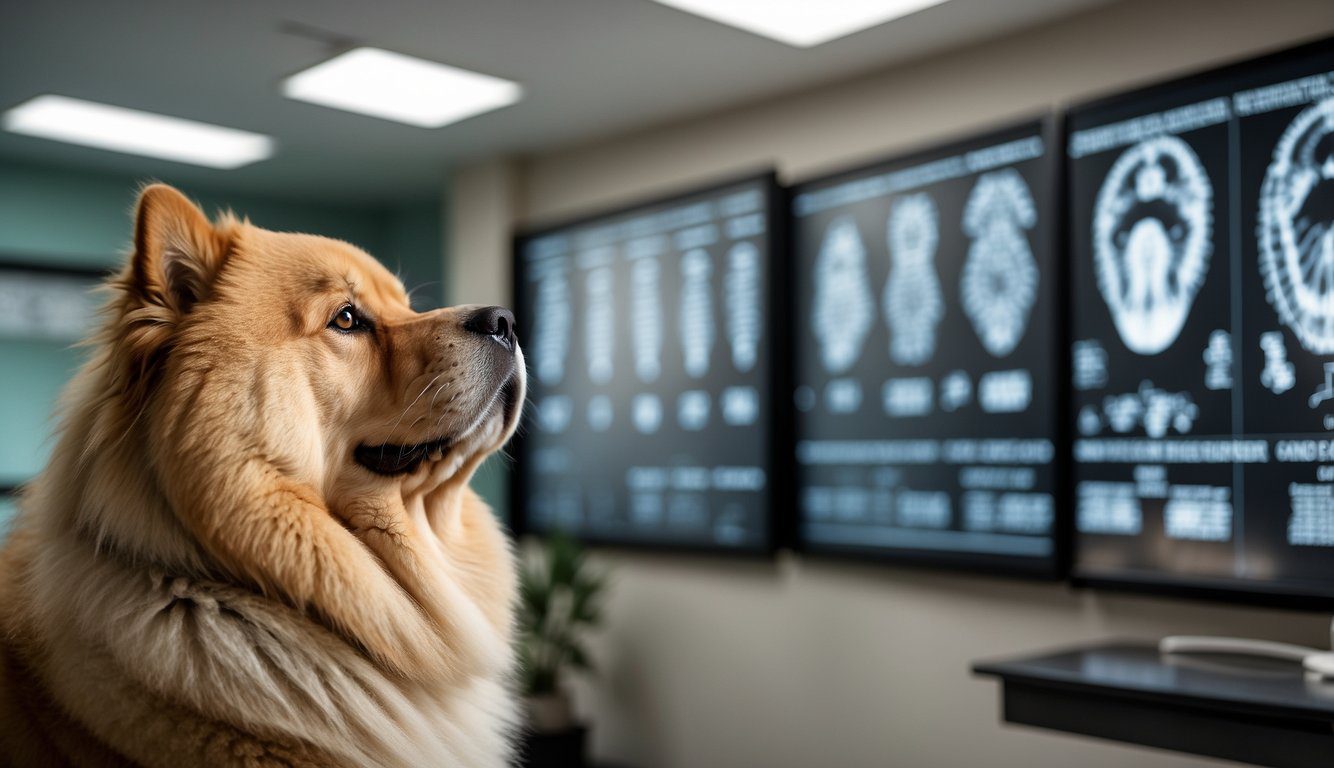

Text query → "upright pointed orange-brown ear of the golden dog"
[131,184,227,317]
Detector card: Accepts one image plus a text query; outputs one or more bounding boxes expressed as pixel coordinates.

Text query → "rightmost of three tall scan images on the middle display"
[959,168,1041,357]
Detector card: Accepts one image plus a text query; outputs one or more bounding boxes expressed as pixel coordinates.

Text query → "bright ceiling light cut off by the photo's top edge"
[658,0,944,48]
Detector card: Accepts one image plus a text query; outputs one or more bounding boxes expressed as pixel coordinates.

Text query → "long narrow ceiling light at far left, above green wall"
[4,95,273,168]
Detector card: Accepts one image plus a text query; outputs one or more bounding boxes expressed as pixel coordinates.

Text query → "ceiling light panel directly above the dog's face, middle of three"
[283,48,523,128]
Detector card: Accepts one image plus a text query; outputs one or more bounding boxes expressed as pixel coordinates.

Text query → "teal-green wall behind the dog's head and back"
[0,161,446,527]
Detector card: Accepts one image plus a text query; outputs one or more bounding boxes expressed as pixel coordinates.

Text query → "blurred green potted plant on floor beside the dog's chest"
[518,533,606,768]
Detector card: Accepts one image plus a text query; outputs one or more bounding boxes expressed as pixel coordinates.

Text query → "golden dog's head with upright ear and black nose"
[118,185,524,503]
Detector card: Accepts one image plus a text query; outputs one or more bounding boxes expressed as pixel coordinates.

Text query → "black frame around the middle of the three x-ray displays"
[787,111,1073,583]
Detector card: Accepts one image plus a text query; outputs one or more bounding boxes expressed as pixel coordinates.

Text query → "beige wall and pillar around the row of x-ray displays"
[451,0,1334,768]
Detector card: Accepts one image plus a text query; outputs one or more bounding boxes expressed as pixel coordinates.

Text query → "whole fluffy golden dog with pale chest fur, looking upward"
[0,185,524,767]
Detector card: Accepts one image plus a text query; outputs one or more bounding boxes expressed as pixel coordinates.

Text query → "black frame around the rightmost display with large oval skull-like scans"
[1061,36,1334,613]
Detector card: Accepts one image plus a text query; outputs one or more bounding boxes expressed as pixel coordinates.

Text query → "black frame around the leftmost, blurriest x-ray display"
[508,168,791,560]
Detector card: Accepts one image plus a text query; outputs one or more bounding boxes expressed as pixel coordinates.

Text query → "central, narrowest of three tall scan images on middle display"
[884,192,944,365]
